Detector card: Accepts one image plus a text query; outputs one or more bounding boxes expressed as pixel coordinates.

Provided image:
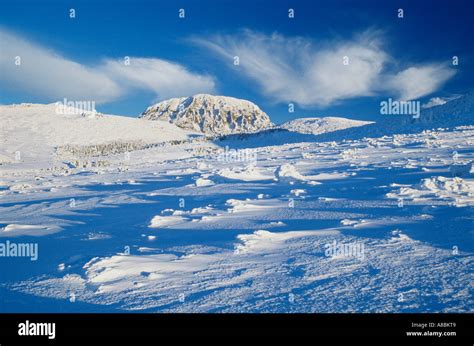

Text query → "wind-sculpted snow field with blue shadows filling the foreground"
[0,101,474,312]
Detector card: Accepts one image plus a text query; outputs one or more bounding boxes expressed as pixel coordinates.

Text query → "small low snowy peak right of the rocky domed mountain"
[279,117,371,135]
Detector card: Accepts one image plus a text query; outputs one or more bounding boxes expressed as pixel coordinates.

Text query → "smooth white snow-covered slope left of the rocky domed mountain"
[0,104,197,170]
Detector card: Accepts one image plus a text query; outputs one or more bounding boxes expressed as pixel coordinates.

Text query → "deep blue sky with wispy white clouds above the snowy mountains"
[0,0,474,123]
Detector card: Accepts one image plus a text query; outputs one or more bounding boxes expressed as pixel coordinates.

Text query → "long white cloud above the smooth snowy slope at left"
[0,28,215,103]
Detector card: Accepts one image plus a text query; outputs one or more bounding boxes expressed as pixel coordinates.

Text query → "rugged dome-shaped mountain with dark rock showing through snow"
[140,94,272,135]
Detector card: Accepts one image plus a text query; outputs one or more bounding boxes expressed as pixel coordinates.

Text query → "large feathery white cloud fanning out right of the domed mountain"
[192,30,454,107]
